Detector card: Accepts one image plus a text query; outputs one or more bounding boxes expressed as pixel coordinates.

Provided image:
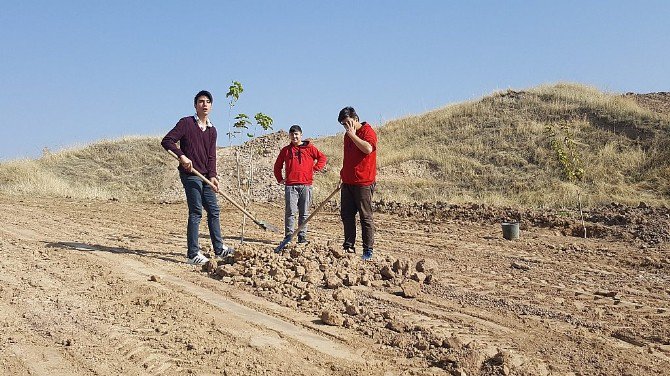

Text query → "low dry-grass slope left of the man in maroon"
[0,137,174,200]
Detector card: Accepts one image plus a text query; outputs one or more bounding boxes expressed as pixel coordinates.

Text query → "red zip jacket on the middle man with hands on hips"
[274,140,328,185]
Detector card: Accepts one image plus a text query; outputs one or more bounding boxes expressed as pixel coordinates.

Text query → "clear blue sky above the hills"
[0,0,670,160]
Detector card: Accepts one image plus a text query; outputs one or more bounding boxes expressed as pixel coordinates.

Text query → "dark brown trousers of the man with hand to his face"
[340,183,375,249]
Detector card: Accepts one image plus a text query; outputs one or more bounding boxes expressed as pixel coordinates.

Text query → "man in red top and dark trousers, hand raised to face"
[337,107,377,261]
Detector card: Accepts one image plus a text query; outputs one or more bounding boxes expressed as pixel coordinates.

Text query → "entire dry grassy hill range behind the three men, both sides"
[0,84,670,207]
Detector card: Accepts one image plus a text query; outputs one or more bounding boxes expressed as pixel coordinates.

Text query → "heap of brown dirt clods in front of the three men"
[203,244,556,374]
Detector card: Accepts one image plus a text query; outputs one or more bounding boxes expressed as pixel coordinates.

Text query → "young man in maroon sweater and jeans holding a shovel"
[161,90,233,265]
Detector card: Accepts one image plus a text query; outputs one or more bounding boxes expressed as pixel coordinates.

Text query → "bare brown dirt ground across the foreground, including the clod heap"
[0,197,670,375]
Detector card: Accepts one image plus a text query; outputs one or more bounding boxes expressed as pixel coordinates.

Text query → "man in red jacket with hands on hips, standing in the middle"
[274,125,327,243]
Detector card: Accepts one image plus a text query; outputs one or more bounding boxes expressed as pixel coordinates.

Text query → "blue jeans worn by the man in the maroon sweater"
[179,172,223,258]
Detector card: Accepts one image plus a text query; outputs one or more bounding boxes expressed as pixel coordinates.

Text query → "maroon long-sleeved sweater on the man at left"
[161,116,216,178]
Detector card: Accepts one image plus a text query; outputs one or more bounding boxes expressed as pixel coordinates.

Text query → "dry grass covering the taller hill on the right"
[317,84,670,207]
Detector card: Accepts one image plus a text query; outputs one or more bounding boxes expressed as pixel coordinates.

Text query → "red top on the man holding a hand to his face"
[340,122,377,186]
